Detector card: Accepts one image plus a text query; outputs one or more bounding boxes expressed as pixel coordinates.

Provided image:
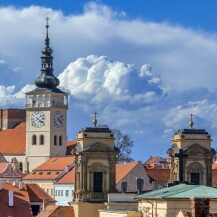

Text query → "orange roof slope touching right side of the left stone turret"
[116,161,139,184]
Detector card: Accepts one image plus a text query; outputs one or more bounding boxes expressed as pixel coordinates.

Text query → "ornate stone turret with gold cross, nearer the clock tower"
[73,113,118,202]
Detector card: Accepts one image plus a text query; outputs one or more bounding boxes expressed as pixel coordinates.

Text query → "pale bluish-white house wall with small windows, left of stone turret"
[54,184,74,205]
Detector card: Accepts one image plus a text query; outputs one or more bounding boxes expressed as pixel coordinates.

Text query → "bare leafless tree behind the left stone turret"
[112,129,134,163]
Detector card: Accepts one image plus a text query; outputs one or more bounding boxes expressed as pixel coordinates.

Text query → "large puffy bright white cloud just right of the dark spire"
[59,55,163,105]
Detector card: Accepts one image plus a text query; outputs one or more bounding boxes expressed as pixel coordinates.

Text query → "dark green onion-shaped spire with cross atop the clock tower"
[35,17,60,89]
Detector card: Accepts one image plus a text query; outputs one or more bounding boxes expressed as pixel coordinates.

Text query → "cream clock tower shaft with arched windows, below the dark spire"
[26,93,68,171]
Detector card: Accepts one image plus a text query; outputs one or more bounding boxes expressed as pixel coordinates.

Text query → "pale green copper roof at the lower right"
[135,184,217,199]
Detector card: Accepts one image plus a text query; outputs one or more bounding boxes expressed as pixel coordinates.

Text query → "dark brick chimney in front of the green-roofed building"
[191,197,209,217]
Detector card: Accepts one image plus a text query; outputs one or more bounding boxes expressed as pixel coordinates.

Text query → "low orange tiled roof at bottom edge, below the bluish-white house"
[37,205,75,217]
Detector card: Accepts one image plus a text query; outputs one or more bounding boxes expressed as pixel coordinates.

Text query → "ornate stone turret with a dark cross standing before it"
[168,114,215,186]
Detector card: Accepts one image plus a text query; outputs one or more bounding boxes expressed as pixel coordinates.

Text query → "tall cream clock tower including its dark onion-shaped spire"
[26,18,68,172]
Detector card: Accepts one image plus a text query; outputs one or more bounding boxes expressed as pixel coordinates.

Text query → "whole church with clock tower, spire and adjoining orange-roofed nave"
[0,20,68,173]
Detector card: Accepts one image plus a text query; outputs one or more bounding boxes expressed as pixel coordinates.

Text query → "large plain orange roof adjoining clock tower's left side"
[0,122,26,154]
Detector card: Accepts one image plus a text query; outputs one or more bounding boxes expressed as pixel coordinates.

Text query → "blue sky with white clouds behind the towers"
[0,0,217,161]
